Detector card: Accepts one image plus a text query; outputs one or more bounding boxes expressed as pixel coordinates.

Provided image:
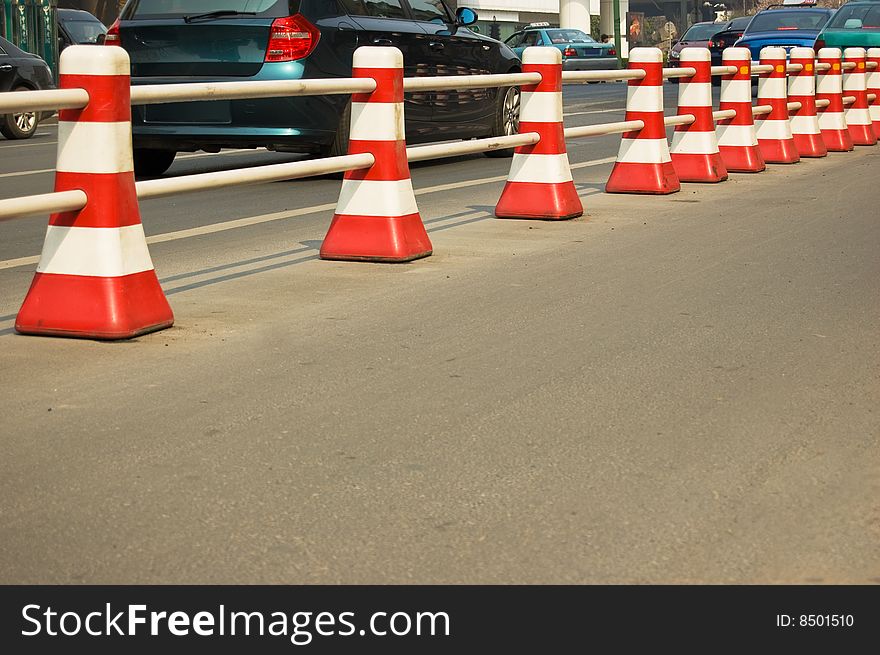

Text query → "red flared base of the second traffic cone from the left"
[320,213,433,263]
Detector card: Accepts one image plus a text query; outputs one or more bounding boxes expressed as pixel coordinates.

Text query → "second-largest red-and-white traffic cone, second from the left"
[320,46,432,262]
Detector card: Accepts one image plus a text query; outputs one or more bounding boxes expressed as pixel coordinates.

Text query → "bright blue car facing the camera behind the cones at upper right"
[734,5,834,61]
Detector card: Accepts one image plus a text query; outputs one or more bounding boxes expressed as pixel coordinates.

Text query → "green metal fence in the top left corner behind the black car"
[0,0,58,79]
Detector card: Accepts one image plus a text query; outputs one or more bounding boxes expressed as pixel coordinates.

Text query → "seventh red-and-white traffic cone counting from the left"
[755,46,801,164]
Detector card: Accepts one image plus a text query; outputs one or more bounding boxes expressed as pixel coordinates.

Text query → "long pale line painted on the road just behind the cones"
[0,157,616,270]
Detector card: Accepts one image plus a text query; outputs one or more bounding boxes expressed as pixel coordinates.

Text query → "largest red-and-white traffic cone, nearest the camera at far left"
[15,46,174,339]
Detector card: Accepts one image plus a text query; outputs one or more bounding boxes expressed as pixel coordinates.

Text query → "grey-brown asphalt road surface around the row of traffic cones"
[0,84,880,583]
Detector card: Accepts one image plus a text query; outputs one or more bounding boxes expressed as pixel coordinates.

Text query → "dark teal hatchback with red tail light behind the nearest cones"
[105,0,521,176]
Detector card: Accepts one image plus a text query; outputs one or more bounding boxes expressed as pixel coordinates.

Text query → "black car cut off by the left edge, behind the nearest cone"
[0,37,55,139]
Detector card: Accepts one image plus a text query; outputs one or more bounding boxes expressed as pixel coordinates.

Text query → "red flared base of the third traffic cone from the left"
[495,182,584,221]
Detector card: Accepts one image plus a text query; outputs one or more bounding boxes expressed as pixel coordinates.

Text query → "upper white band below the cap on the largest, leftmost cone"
[55,121,134,173]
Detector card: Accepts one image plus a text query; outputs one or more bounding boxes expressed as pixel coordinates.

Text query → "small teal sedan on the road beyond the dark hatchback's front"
[504,23,620,71]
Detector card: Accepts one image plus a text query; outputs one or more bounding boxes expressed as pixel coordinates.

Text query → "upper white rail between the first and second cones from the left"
[131,77,376,105]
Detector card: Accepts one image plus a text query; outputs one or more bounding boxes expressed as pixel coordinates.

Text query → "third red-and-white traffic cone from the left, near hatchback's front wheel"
[495,47,584,220]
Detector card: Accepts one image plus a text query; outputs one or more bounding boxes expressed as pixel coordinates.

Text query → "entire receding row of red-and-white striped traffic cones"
[15,46,880,339]
